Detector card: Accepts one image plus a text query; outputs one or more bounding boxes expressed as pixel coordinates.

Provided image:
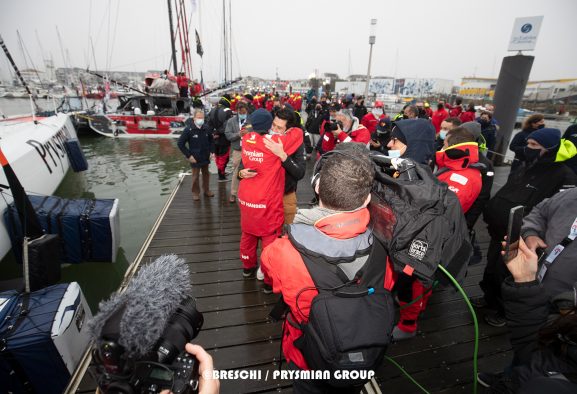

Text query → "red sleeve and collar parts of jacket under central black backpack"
[261,208,394,370]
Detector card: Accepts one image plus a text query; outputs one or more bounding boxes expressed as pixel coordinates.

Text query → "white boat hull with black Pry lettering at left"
[0,114,76,259]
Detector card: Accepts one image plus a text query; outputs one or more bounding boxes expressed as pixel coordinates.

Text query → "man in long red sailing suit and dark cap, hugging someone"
[237,108,303,293]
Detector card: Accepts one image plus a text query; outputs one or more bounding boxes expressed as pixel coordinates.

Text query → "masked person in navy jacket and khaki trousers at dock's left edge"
[178,108,214,201]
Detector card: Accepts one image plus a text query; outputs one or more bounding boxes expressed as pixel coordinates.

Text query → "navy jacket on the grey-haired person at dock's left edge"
[178,119,214,167]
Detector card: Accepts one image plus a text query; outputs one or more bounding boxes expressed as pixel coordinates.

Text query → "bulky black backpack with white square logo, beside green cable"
[369,157,472,284]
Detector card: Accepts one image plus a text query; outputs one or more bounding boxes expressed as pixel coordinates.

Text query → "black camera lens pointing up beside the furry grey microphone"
[157,298,204,364]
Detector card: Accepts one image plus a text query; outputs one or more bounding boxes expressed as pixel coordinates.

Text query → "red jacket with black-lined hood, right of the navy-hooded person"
[435,142,483,213]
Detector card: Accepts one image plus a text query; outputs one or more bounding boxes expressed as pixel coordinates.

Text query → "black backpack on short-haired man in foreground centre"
[288,230,395,387]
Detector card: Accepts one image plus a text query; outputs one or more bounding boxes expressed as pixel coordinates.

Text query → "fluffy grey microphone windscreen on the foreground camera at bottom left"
[90,254,192,357]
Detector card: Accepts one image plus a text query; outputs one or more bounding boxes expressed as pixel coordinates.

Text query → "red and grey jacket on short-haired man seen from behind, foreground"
[261,208,393,370]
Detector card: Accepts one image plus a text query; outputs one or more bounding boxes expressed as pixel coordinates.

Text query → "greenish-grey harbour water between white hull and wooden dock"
[0,100,189,312]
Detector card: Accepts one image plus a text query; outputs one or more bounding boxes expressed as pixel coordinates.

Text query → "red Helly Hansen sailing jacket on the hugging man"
[238,127,303,236]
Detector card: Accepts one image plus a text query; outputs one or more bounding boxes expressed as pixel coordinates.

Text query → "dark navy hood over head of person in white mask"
[395,119,435,164]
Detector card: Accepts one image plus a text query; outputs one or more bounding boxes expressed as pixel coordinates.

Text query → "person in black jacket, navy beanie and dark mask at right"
[472,128,577,327]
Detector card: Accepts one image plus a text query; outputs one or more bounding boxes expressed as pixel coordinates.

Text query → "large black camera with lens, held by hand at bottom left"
[90,297,204,394]
